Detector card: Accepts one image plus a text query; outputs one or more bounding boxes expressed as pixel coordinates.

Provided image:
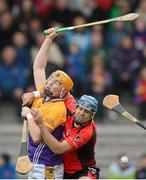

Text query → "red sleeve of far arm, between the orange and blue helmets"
[65,96,77,112]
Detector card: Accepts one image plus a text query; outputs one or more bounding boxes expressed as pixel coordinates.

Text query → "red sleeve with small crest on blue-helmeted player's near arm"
[65,128,93,150]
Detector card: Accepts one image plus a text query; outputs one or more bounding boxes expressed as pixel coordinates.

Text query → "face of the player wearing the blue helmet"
[74,106,92,123]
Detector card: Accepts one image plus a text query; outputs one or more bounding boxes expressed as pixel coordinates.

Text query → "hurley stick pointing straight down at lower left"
[16,120,33,175]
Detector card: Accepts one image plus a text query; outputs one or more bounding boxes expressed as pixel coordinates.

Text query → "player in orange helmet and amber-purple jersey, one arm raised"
[22,28,73,179]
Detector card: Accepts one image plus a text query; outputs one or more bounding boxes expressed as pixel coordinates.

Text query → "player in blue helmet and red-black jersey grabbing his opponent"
[31,95,99,179]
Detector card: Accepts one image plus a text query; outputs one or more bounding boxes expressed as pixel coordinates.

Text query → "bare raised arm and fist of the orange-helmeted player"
[33,28,57,89]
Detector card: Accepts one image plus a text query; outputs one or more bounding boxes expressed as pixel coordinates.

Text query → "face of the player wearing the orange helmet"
[44,74,63,97]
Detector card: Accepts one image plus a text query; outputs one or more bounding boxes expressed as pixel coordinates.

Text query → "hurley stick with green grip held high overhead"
[44,13,139,35]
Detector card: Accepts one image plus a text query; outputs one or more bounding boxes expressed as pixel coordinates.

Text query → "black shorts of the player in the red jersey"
[64,167,100,179]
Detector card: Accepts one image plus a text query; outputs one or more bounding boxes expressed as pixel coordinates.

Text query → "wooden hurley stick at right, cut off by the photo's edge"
[103,95,146,130]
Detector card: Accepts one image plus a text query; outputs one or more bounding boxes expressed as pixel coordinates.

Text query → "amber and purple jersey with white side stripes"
[28,98,66,166]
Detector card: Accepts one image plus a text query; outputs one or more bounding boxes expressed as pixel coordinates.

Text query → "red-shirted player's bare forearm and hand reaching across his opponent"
[31,108,71,154]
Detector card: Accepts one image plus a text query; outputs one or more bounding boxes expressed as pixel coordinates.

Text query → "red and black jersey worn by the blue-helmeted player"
[62,95,97,174]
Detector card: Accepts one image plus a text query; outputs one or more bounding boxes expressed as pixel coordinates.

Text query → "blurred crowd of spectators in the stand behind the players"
[0,0,146,121]
